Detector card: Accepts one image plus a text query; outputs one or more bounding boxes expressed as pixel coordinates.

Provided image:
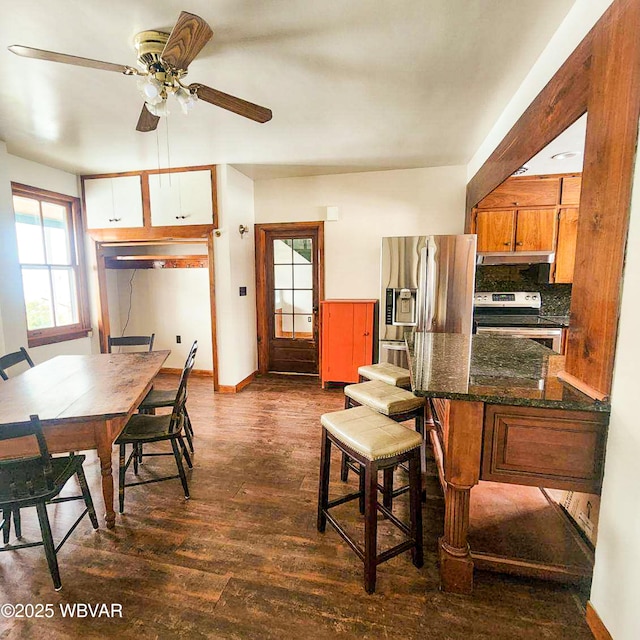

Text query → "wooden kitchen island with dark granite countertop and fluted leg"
[406,332,610,593]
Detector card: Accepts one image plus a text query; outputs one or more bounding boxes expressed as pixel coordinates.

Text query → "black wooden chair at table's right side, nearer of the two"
[116,342,195,513]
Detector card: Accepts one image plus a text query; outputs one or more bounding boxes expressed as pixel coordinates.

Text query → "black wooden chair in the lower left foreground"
[0,415,98,591]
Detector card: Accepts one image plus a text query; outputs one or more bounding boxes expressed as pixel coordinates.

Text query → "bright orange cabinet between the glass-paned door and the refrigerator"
[320,300,378,387]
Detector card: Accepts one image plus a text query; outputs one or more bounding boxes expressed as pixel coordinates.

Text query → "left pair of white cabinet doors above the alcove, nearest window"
[84,176,144,229]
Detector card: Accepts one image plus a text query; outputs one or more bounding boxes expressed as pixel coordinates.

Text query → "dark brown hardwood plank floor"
[0,376,591,640]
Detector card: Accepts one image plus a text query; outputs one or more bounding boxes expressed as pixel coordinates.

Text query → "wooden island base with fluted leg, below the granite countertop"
[429,399,609,594]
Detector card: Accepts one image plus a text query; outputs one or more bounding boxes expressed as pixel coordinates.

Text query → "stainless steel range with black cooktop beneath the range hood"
[473,291,566,353]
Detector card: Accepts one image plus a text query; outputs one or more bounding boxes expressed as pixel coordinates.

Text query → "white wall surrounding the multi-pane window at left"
[0,142,92,363]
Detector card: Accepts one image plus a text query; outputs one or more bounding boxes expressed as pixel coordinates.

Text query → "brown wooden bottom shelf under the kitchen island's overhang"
[469,481,594,583]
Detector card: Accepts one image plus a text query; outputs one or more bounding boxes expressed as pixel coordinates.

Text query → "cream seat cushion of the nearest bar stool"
[320,407,422,460]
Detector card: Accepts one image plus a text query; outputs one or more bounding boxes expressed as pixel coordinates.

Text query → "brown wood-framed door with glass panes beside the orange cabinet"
[255,222,324,374]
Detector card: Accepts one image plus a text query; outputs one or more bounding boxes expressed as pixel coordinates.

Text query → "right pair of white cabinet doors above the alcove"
[149,169,213,227]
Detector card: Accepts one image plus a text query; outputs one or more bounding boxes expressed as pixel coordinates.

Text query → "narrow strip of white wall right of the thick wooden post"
[591,151,640,640]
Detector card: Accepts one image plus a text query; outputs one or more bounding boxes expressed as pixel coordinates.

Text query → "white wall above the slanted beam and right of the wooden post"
[468,0,640,640]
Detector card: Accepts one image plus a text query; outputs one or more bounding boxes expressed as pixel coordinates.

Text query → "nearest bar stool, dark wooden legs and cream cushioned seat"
[317,407,423,593]
